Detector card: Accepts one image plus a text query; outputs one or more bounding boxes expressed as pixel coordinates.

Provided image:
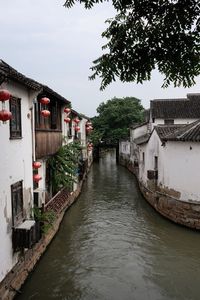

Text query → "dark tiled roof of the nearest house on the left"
[0,60,42,91]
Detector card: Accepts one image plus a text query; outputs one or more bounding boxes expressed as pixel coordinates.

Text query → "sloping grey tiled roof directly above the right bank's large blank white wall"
[164,120,200,142]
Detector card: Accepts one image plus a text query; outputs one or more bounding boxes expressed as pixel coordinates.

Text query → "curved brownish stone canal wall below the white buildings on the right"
[119,157,200,230]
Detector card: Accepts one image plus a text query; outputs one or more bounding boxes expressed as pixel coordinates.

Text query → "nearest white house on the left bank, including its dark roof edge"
[0,60,41,281]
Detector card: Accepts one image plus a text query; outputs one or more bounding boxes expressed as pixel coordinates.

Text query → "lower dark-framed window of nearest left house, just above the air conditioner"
[11,181,23,226]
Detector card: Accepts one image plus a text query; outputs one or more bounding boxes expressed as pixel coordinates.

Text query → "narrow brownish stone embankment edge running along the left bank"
[0,176,86,300]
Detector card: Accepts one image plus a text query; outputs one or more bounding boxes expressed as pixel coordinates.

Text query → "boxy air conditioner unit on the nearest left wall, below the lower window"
[12,220,41,251]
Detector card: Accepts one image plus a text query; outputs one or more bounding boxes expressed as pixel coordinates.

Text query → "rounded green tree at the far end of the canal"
[91,97,144,145]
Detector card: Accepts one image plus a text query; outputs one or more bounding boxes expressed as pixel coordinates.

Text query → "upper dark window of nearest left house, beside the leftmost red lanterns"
[10,97,22,139]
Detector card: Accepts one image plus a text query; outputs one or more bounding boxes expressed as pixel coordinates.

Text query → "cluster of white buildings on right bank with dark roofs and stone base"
[130,94,200,229]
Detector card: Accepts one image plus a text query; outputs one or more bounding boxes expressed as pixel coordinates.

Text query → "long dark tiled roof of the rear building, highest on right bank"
[150,94,200,119]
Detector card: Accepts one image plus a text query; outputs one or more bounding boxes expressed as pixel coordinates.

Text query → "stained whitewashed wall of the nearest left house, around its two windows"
[0,83,37,281]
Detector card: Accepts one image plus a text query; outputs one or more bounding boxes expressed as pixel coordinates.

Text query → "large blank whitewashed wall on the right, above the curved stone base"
[161,141,200,201]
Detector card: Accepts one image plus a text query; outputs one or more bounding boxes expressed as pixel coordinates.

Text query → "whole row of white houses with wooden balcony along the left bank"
[0,60,92,288]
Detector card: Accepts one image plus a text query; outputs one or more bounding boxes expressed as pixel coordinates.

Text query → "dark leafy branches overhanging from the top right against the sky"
[64,0,200,90]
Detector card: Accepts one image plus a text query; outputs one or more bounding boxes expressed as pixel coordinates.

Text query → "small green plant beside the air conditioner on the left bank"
[33,207,56,233]
